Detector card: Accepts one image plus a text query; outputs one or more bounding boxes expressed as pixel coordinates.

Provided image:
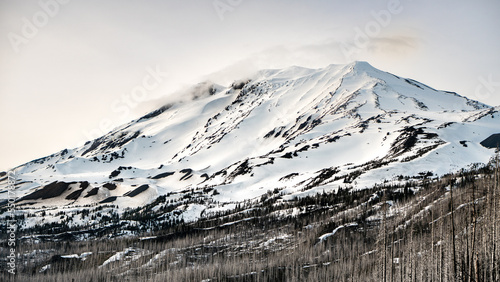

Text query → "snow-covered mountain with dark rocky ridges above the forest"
[0,62,500,231]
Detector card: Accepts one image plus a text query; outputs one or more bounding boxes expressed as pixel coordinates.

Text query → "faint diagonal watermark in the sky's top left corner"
[7,0,70,53]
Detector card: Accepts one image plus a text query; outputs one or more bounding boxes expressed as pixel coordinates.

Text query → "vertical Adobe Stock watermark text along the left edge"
[5,171,17,274]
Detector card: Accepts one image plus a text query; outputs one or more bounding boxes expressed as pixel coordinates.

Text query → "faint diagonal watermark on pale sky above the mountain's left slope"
[83,65,168,140]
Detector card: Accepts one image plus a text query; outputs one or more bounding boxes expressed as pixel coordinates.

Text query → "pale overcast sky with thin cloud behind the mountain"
[0,0,500,171]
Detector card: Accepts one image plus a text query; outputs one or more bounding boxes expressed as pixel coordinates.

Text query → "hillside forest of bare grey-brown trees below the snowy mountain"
[1,154,500,282]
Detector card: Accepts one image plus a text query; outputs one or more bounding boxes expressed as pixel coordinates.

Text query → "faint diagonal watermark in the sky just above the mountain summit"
[339,0,403,61]
